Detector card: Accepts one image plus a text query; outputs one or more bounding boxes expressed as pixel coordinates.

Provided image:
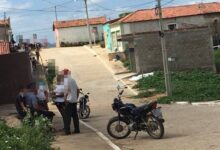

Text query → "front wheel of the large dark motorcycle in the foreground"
[107,117,131,139]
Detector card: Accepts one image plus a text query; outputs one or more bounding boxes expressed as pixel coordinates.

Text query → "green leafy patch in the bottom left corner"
[0,112,53,150]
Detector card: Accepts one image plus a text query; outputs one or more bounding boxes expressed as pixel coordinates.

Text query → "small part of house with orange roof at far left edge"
[0,18,11,41]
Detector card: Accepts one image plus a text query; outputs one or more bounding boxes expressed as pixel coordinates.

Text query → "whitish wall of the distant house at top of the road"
[57,25,103,45]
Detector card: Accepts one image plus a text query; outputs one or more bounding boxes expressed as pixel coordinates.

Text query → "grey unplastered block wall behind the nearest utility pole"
[131,28,215,73]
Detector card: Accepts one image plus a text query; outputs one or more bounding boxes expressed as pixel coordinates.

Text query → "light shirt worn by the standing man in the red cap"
[64,77,78,103]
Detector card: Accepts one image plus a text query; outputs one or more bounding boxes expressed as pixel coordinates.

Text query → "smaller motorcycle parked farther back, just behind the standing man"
[78,89,90,119]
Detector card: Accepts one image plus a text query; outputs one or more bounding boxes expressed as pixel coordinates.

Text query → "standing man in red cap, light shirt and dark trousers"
[64,69,80,135]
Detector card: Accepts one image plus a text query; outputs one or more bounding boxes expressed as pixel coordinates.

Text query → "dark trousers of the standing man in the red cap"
[64,103,79,133]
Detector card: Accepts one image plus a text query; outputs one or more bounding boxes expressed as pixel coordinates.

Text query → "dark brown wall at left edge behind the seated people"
[0,52,32,105]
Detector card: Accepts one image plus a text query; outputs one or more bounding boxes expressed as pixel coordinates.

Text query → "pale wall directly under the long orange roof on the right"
[121,13,220,49]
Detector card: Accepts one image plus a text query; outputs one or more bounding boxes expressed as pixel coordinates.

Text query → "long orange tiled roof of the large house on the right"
[118,2,220,23]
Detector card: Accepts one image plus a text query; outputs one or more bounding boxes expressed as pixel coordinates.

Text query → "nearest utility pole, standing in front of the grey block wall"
[157,0,172,96]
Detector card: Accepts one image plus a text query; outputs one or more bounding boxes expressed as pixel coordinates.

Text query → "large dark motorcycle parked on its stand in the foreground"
[107,85,164,139]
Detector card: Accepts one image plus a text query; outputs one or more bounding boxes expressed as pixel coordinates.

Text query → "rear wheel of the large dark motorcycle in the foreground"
[147,116,164,139]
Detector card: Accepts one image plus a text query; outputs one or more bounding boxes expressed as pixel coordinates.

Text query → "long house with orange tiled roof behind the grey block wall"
[110,2,220,51]
